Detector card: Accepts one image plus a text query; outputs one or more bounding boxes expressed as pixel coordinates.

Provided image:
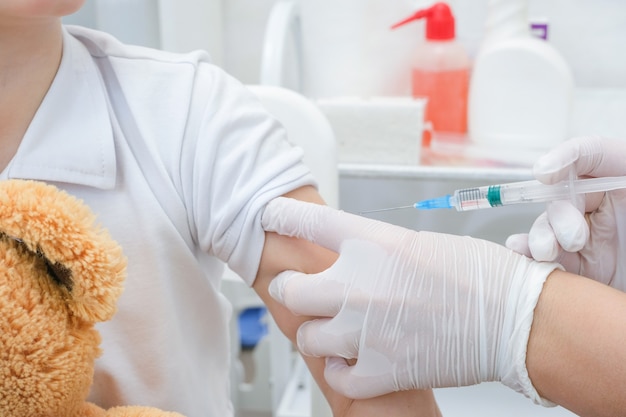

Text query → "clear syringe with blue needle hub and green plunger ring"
[360,176,626,214]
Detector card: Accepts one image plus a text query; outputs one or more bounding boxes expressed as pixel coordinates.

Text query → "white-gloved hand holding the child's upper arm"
[262,198,558,405]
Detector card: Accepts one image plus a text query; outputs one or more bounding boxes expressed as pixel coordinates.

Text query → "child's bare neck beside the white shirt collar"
[0,22,62,171]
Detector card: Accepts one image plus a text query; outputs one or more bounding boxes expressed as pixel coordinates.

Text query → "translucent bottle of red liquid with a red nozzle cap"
[391,3,470,146]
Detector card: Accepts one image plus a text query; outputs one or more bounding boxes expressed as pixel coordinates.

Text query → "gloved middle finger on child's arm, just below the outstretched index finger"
[269,271,345,317]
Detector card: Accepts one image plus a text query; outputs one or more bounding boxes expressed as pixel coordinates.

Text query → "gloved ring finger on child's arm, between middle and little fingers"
[296,319,361,359]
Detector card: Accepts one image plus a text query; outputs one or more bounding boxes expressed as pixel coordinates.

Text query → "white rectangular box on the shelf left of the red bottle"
[316,97,426,165]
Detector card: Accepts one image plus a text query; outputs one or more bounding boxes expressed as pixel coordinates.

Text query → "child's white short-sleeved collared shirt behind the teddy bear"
[2,26,313,417]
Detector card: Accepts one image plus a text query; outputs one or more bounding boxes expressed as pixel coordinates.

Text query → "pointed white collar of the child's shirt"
[6,28,116,189]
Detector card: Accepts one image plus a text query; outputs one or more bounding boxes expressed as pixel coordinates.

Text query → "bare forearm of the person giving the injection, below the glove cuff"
[527,271,626,417]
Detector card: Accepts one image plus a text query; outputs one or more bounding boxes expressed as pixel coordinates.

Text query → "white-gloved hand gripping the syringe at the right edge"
[506,137,626,291]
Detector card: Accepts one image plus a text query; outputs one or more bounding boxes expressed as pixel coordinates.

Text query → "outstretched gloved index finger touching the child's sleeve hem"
[261,197,405,252]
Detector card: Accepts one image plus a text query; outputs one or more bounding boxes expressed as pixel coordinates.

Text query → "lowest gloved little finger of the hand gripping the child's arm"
[324,357,382,400]
